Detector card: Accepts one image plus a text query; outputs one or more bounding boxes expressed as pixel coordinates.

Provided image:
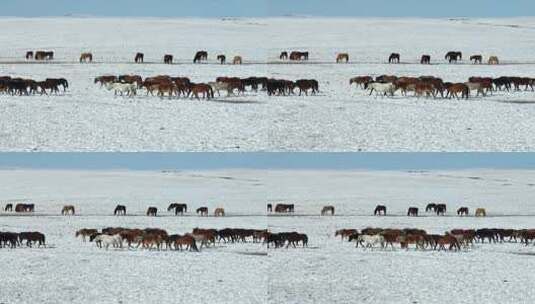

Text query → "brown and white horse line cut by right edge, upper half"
[349,75,535,99]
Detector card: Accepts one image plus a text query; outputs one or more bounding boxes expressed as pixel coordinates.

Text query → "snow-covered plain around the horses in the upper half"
[0,18,535,151]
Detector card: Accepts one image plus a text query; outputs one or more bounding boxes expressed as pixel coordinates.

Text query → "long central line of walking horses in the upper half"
[94,75,319,99]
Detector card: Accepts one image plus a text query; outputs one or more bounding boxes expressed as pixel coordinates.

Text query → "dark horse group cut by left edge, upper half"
[0,76,69,96]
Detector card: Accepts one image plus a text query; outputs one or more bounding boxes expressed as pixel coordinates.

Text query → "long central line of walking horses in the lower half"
[75,227,308,251]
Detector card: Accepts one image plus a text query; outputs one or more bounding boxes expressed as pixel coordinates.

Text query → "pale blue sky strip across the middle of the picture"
[0,153,535,171]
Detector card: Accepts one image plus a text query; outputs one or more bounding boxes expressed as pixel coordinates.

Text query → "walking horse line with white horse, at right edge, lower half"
[334,227,535,251]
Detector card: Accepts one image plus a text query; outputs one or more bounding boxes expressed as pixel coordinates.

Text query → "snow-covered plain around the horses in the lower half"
[0,170,535,303]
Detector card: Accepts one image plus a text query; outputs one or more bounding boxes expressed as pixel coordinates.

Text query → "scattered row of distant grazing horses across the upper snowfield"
[19,50,500,65]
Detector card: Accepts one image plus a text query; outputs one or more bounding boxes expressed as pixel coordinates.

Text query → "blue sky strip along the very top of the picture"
[0,0,535,17]
